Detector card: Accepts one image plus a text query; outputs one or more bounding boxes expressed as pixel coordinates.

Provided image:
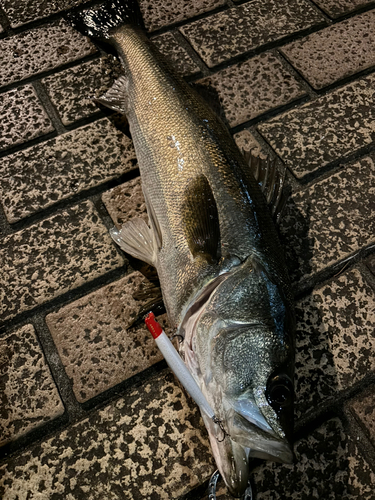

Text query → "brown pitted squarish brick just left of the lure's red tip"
[46,271,170,403]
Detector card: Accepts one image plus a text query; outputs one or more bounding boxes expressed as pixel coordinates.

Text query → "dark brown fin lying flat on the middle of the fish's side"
[182,175,220,261]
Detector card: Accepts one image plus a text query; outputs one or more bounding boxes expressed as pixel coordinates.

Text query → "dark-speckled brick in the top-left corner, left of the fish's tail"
[1,0,88,28]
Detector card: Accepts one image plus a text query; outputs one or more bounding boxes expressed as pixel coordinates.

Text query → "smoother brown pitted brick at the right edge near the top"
[281,11,375,89]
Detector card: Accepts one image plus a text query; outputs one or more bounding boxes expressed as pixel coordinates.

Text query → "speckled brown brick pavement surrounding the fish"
[0,0,375,500]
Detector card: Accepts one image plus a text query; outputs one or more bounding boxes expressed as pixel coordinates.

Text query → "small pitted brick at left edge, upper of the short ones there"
[0,85,53,150]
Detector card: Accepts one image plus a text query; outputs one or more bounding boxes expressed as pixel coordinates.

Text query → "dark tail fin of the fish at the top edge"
[65,0,144,40]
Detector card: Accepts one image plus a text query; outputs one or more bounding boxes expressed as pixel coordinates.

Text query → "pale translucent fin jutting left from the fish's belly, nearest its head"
[110,218,158,266]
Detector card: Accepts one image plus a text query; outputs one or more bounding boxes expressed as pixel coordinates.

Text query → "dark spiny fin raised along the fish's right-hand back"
[242,150,289,223]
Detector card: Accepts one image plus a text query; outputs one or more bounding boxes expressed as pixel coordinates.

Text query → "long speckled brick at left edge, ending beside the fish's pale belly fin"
[0,202,123,321]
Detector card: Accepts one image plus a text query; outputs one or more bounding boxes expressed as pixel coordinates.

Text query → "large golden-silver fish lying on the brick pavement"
[69,0,295,497]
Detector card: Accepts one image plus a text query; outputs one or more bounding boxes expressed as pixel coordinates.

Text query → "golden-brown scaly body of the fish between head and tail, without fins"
[113,27,290,324]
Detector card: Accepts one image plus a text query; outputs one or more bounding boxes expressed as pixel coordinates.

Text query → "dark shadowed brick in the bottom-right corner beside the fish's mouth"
[253,418,375,500]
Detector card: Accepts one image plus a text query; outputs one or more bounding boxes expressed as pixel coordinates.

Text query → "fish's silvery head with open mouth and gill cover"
[185,261,295,496]
